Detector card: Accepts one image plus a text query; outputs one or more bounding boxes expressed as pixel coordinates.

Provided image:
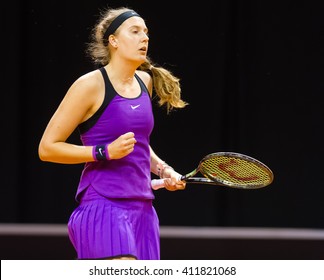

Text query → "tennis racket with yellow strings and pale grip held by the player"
[151,152,274,190]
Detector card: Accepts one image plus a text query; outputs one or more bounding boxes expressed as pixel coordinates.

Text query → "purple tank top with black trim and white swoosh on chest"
[76,68,154,202]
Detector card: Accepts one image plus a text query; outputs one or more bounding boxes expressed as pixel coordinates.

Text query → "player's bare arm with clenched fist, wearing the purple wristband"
[38,71,136,164]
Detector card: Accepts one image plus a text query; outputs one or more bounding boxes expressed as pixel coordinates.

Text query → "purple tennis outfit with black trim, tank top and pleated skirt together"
[68,68,160,260]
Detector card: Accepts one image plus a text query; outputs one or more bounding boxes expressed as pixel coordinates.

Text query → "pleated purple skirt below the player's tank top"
[68,187,160,260]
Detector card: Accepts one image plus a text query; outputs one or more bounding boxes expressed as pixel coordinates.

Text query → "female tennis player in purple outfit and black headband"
[39,7,187,260]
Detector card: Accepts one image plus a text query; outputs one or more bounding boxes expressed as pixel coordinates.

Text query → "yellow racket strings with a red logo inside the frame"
[201,156,272,186]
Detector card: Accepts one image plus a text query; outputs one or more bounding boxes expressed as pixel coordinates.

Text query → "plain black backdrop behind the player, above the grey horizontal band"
[0,0,324,228]
